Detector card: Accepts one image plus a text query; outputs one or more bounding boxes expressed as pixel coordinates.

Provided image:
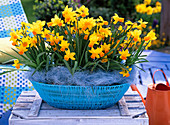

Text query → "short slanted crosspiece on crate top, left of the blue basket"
[28,93,42,117]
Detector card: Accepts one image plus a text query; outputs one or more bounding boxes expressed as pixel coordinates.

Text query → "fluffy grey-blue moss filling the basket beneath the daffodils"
[26,66,138,86]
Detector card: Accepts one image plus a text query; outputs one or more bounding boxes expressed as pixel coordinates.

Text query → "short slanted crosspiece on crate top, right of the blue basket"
[118,97,130,116]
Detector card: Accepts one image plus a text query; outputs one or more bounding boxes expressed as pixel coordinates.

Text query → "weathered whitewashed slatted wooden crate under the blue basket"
[9,90,148,125]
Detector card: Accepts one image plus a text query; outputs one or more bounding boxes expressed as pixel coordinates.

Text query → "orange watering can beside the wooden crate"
[131,70,170,125]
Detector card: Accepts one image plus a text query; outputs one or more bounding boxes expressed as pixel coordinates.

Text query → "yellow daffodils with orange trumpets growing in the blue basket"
[10,5,156,77]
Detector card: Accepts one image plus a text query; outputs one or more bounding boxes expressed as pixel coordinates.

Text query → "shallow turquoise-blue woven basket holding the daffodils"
[31,81,130,109]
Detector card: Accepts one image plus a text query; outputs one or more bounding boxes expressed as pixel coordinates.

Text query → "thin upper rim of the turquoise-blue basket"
[30,80,130,88]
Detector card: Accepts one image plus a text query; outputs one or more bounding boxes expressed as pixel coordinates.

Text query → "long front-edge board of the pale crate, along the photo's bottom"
[9,114,148,125]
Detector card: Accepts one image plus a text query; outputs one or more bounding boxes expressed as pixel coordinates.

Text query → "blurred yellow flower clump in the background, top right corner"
[136,0,161,15]
